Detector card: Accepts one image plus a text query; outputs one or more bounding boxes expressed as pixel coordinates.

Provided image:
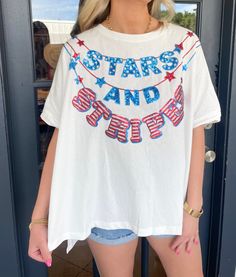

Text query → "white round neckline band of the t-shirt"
[95,23,170,42]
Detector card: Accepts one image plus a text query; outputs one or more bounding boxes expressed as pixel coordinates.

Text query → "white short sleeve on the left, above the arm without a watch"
[40,45,69,128]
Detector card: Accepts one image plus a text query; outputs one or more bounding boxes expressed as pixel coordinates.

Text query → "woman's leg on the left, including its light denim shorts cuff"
[87,227,138,277]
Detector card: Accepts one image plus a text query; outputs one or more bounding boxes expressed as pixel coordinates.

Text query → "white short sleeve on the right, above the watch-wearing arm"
[183,33,221,128]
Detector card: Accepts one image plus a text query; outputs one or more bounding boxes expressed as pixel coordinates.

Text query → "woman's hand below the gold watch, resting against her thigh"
[170,211,199,255]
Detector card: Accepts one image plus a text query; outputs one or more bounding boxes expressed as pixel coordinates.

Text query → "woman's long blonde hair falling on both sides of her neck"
[70,0,175,37]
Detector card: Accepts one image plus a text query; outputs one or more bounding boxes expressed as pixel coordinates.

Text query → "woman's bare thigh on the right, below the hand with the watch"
[146,233,203,277]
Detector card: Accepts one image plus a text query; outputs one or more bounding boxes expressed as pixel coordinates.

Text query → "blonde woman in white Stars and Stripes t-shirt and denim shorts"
[29,0,221,277]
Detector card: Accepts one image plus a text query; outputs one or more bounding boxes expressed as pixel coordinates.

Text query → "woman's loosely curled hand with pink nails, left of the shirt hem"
[28,224,52,267]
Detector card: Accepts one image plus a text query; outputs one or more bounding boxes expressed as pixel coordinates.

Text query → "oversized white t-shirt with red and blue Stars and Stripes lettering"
[40,23,221,253]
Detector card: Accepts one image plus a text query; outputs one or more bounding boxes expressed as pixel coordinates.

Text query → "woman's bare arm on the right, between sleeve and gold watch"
[186,125,205,210]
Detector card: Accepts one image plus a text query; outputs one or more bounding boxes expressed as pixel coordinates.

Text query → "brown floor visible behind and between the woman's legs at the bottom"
[48,239,166,277]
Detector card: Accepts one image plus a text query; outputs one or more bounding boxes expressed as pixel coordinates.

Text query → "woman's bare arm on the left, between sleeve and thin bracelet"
[31,128,58,220]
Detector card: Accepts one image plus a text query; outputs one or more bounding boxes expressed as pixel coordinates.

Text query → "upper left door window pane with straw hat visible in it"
[31,0,78,81]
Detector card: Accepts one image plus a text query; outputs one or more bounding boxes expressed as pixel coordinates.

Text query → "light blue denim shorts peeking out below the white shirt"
[88,227,176,244]
